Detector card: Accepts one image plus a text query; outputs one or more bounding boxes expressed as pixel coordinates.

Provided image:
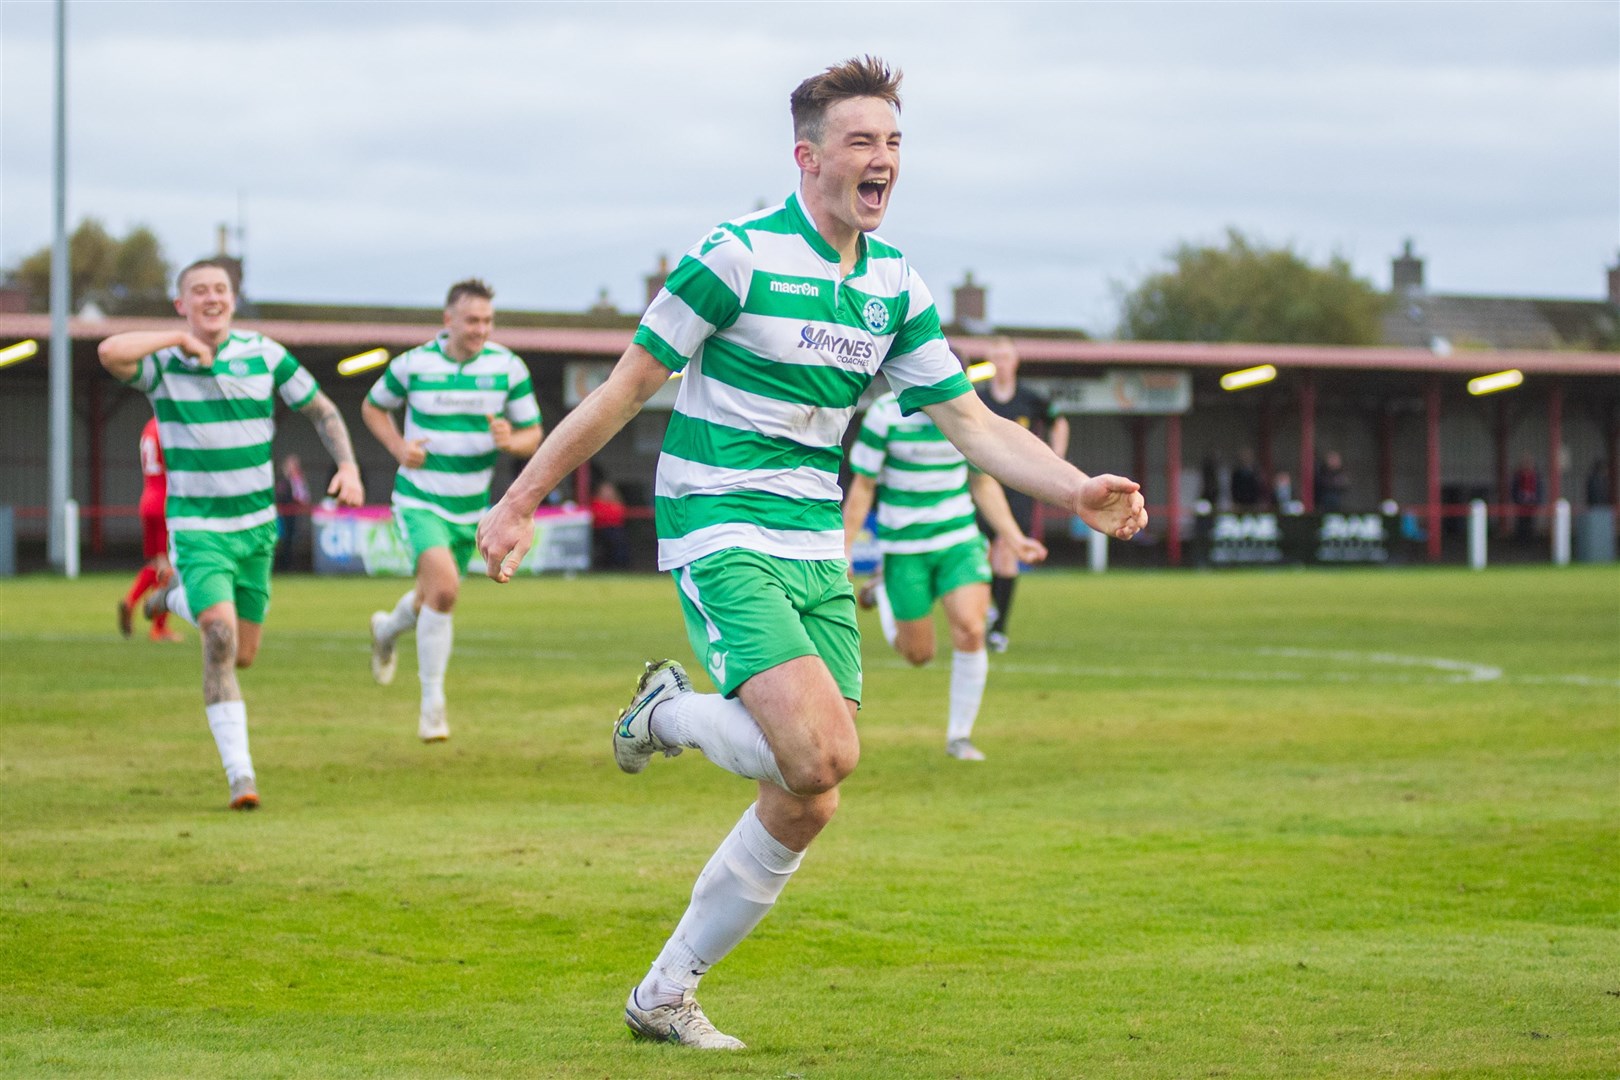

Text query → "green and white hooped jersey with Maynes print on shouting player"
[635,196,972,570]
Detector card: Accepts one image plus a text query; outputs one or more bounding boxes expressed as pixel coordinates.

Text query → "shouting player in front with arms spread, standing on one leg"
[478,57,1147,1049]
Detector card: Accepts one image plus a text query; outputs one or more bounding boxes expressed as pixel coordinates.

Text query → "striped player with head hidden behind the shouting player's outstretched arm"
[844,393,1047,761]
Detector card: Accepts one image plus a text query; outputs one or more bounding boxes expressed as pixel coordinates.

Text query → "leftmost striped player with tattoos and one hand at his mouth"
[99,259,366,810]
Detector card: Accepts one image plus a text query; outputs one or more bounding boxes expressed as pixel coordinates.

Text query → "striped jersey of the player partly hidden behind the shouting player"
[849,393,980,555]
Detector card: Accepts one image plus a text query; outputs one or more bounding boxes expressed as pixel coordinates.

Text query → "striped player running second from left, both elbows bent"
[360,279,543,743]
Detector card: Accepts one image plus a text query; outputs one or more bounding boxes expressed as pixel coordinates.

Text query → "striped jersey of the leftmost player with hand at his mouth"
[128,330,321,533]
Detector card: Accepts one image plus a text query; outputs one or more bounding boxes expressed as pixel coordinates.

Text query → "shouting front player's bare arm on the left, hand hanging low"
[478,345,669,581]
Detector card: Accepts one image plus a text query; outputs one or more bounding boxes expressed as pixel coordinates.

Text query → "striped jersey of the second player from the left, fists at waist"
[366,332,539,525]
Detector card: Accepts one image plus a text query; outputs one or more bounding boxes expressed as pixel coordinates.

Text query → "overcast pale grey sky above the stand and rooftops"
[0,0,1620,334]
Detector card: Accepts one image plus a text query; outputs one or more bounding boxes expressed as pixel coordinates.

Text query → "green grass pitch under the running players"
[0,567,1620,1080]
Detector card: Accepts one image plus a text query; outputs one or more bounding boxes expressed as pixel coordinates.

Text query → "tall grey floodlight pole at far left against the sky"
[45,0,78,570]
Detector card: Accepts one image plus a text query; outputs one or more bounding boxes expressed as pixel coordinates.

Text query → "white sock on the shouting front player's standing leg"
[635,806,804,1009]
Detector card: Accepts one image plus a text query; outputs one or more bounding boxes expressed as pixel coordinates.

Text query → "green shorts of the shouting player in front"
[671,547,860,703]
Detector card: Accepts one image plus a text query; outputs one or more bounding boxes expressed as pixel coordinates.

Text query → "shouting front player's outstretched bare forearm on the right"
[923,393,1147,539]
